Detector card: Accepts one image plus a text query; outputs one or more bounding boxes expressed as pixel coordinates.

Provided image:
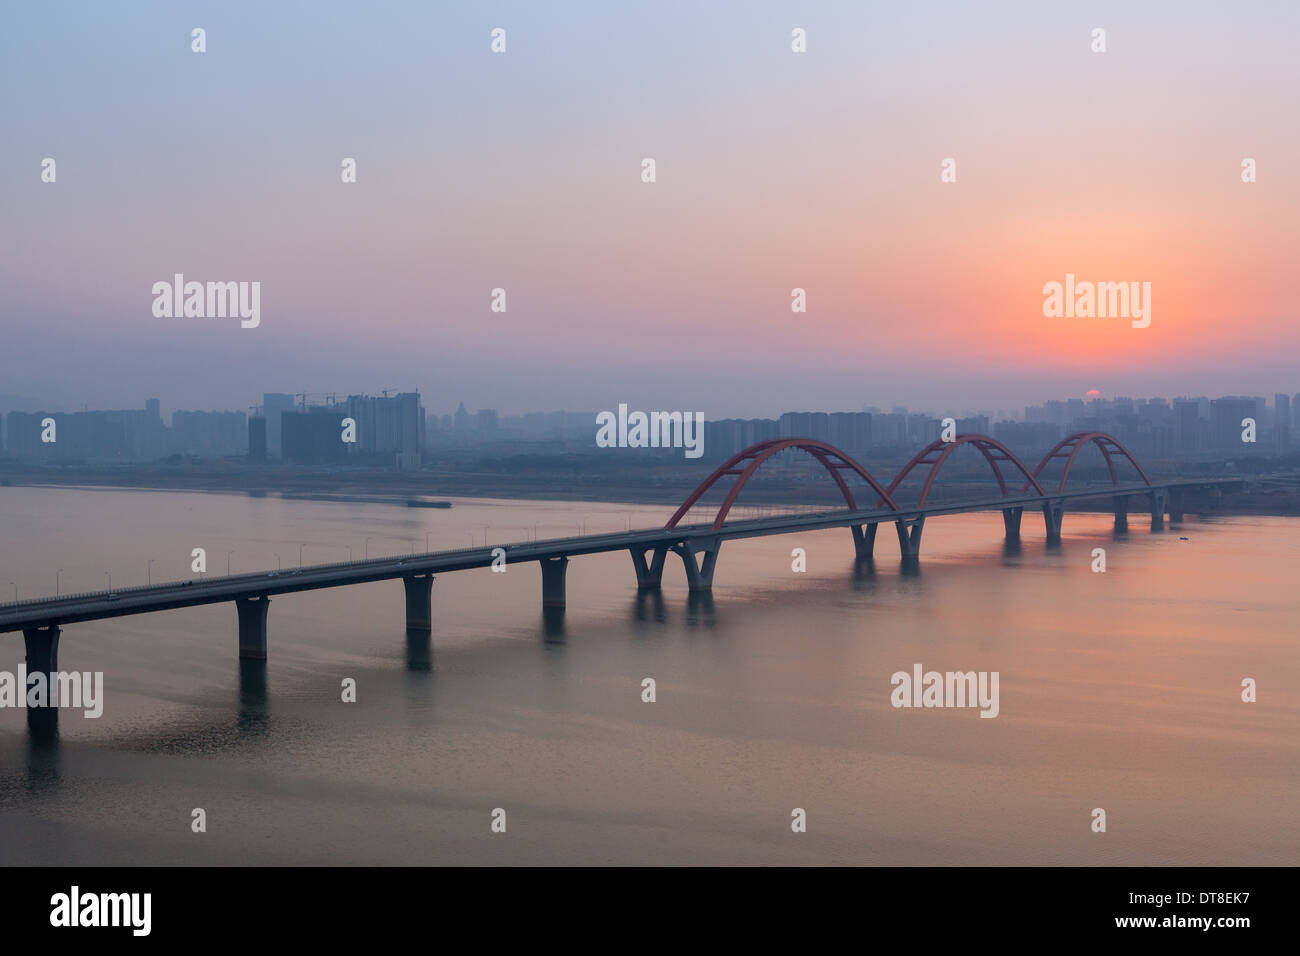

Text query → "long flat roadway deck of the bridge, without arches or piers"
[0,479,1242,632]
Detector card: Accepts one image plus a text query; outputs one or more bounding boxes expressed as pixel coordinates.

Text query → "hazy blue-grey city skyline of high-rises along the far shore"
[0,390,1300,471]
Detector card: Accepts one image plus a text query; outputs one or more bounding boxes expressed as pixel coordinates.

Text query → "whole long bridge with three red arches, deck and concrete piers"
[0,432,1243,723]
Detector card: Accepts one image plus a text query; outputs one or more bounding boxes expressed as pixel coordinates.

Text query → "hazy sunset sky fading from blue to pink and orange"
[0,0,1300,419]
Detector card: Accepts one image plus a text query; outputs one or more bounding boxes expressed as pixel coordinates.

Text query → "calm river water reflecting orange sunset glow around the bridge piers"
[0,488,1300,865]
